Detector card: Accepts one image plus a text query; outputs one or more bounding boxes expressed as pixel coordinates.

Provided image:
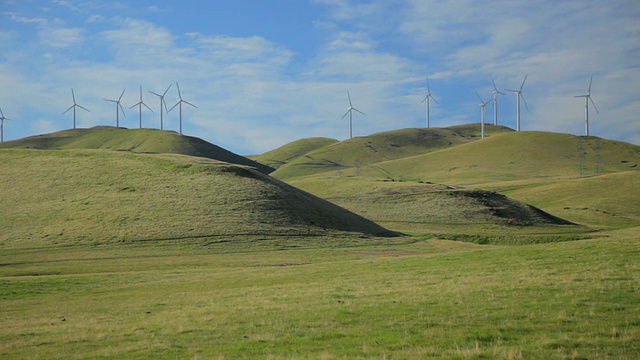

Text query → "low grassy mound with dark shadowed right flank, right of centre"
[291,176,571,236]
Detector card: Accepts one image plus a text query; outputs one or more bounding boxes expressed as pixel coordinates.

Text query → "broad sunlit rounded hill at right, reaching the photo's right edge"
[370,132,640,185]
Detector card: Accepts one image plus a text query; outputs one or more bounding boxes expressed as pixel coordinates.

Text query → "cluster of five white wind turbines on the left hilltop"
[63,82,197,135]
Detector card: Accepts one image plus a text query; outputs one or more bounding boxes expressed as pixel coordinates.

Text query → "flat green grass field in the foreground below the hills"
[0,232,640,359]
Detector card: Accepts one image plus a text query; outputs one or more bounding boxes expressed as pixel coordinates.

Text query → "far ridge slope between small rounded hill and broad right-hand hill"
[272,124,513,179]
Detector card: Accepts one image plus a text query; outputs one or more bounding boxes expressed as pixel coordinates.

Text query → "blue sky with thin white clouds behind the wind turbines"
[0,0,640,154]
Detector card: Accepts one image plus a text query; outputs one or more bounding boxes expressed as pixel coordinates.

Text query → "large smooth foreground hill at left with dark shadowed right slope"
[0,149,393,247]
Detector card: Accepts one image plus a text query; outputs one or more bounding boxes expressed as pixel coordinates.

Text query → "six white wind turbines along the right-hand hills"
[342,75,600,139]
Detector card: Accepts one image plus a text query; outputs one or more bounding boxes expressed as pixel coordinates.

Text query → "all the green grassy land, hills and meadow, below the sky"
[0,125,640,359]
